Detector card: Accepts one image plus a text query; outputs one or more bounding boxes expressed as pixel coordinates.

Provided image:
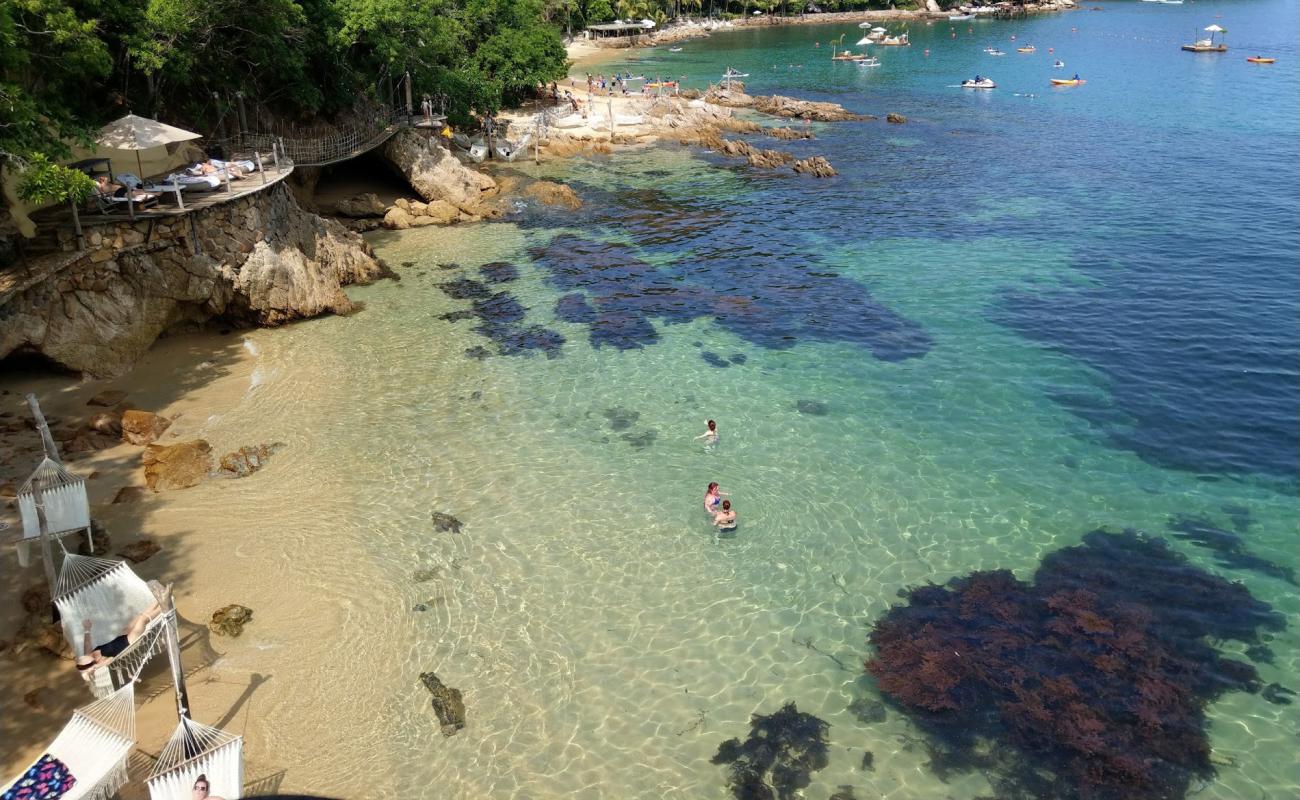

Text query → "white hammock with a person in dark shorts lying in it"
[55,553,176,697]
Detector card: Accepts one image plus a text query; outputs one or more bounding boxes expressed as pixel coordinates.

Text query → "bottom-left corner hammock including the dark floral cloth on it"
[0,683,135,800]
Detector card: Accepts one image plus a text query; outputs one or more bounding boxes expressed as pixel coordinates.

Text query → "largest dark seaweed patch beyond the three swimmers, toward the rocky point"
[529,232,931,363]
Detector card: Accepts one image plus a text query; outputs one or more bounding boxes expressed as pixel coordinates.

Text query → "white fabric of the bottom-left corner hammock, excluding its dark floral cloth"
[0,683,135,800]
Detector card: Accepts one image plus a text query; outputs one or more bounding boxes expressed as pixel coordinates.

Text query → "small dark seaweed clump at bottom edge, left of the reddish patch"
[712,702,831,800]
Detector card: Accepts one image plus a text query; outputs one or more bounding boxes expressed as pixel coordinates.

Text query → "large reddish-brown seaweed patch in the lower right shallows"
[867,531,1284,800]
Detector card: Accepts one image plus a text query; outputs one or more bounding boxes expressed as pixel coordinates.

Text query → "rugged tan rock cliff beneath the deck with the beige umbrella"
[0,183,386,377]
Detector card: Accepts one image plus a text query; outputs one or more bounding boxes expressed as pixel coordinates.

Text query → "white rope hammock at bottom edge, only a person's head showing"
[148,719,243,800]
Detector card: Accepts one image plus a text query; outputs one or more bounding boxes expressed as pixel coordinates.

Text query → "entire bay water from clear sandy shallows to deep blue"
[208,3,1300,799]
